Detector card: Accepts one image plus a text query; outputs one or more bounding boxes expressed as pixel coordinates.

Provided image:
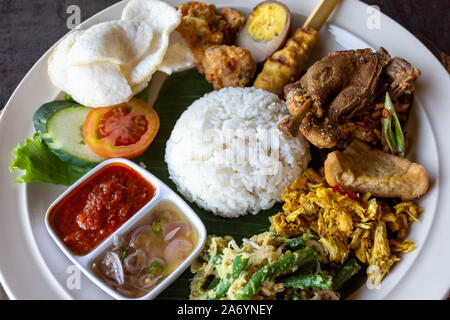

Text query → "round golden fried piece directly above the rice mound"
[203,45,256,90]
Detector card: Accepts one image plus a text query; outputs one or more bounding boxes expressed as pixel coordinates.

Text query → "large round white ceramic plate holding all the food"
[0,0,450,299]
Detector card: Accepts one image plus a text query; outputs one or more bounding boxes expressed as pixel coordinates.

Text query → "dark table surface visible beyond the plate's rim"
[0,0,450,299]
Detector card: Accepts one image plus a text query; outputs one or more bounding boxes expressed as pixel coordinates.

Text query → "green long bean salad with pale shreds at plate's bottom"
[190,232,361,300]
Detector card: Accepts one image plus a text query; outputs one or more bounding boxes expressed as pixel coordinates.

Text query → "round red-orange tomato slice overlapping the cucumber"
[83,98,159,159]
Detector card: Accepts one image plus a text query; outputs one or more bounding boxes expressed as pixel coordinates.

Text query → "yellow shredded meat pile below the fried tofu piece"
[271,168,422,284]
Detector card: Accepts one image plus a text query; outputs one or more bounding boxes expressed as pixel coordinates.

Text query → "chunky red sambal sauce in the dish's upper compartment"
[50,163,155,255]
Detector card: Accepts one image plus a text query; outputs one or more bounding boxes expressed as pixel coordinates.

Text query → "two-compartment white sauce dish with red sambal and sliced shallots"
[45,158,206,300]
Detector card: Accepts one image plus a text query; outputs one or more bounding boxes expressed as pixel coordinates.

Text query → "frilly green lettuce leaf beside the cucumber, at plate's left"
[9,134,91,186]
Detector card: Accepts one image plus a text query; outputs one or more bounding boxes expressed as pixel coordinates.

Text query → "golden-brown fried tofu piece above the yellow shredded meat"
[324,139,428,200]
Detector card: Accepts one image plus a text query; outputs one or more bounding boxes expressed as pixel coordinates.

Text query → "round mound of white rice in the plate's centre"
[165,88,310,217]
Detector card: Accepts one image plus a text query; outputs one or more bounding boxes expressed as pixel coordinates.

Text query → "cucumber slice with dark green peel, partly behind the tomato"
[33,101,106,167]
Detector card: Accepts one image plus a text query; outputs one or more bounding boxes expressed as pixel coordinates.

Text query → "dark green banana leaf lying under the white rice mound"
[135,69,281,299]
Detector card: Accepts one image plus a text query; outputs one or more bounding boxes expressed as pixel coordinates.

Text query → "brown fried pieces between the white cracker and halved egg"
[176,1,245,74]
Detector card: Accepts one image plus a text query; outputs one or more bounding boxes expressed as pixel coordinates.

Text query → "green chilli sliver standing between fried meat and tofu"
[383,92,405,157]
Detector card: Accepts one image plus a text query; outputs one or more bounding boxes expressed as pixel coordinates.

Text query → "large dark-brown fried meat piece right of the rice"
[279,48,420,148]
